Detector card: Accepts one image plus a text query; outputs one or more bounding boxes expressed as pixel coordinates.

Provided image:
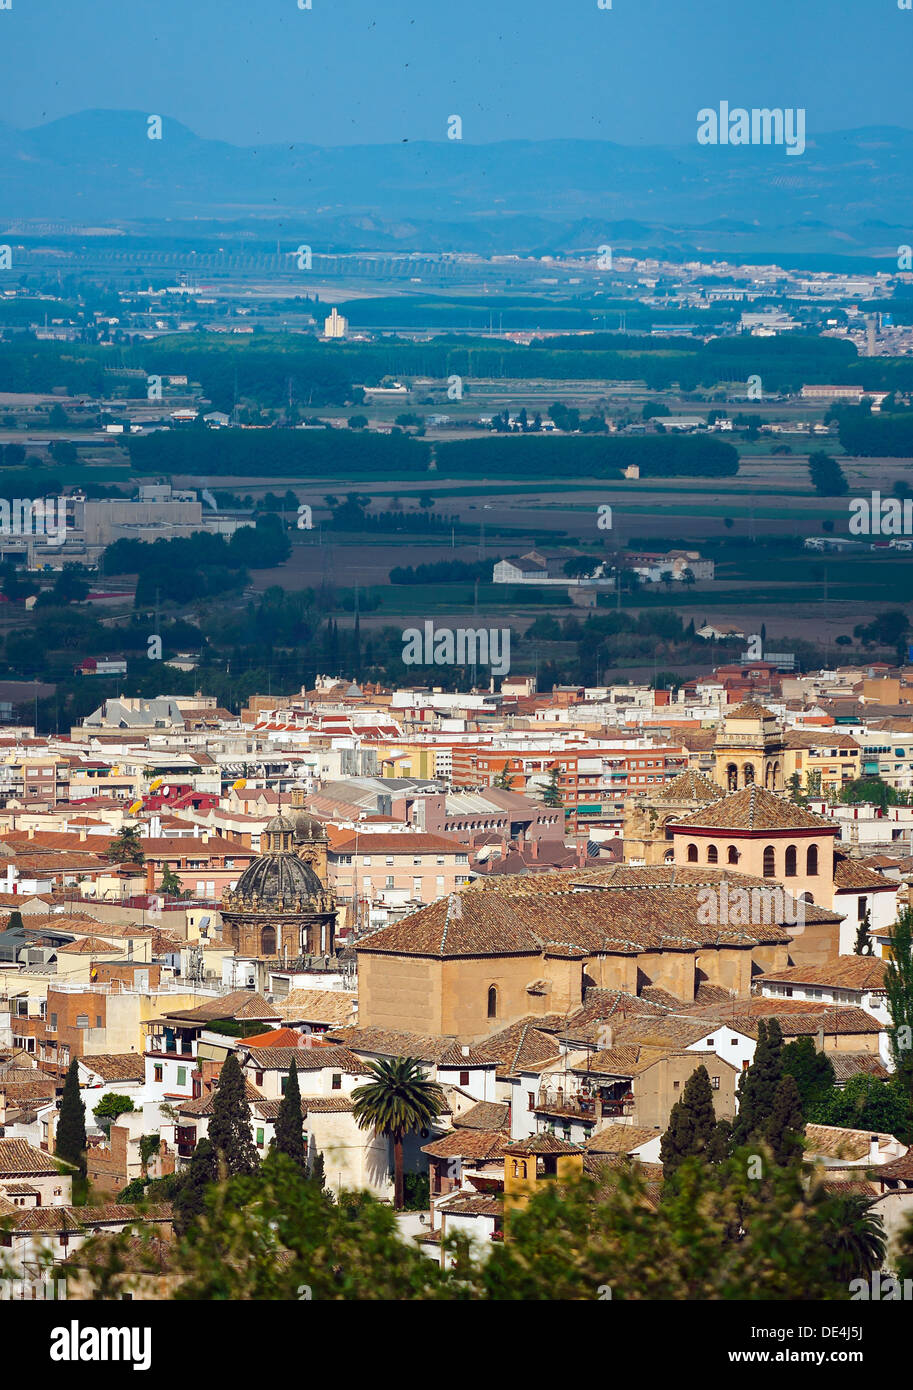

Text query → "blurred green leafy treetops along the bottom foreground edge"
[71,1150,894,1302]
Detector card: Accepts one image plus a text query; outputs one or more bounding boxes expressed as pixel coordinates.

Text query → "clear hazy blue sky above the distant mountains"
[0,0,913,145]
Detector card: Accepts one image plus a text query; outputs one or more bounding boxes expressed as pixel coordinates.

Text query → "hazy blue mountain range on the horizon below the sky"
[0,111,913,256]
